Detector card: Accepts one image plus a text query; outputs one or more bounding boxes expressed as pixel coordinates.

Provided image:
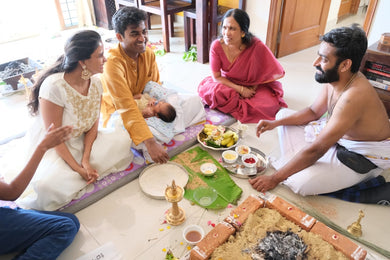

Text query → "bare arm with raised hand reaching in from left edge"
[0,124,72,201]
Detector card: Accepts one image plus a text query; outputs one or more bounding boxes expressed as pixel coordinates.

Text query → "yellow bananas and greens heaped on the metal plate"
[199,124,238,148]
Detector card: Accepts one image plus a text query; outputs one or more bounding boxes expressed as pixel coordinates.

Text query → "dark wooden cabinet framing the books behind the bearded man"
[360,41,390,118]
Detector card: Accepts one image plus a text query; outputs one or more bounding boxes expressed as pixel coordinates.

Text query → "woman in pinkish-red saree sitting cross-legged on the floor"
[198,9,287,123]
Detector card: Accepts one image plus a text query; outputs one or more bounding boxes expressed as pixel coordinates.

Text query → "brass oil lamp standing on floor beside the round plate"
[165,180,185,226]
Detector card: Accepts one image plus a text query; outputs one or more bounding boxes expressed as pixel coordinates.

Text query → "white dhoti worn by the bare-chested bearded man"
[273,109,390,196]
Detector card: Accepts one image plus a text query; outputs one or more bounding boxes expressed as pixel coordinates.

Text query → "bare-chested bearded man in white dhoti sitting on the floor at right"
[249,25,390,203]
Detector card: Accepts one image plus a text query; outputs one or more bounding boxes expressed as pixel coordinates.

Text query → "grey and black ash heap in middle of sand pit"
[247,231,307,260]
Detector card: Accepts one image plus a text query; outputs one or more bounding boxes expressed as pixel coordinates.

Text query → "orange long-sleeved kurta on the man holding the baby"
[101,44,160,145]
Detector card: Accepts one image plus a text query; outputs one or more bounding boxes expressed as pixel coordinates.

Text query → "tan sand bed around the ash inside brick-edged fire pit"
[211,208,348,260]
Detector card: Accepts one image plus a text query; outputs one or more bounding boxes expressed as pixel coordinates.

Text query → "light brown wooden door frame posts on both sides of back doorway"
[266,0,378,54]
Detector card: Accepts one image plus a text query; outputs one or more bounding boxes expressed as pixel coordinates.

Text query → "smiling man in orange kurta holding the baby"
[101,7,169,163]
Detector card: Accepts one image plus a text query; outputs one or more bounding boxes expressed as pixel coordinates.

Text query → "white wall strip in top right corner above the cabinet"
[368,0,390,45]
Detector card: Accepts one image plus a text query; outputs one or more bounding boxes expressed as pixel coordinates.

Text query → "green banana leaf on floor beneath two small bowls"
[171,146,242,209]
